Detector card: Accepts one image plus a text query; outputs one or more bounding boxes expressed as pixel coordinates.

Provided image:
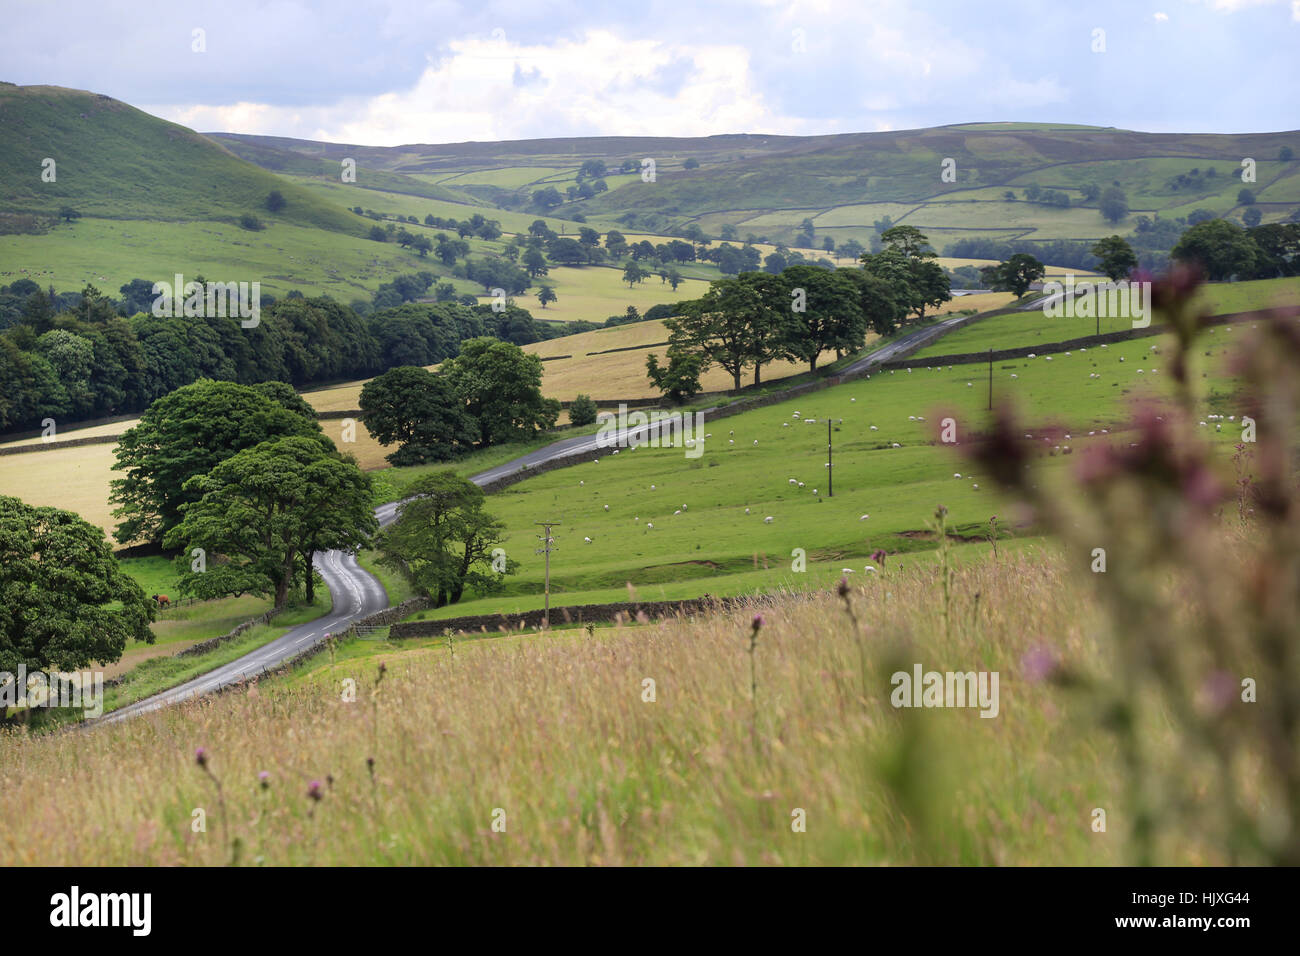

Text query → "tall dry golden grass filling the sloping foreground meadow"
[0,555,1138,865]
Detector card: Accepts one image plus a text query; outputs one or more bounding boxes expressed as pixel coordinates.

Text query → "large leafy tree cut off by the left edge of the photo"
[0,496,153,674]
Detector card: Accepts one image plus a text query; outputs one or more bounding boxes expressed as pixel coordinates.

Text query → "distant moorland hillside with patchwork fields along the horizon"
[211,124,1300,247]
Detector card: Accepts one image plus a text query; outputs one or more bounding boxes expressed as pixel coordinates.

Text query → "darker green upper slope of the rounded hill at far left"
[0,83,363,235]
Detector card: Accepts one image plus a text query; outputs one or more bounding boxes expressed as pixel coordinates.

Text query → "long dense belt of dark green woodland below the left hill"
[0,273,577,432]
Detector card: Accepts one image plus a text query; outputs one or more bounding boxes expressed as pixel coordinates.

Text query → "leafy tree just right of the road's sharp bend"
[376,471,514,607]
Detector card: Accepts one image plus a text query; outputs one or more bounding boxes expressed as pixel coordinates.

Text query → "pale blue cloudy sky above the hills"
[0,0,1300,146]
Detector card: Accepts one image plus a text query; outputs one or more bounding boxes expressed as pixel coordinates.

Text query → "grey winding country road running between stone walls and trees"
[94,316,969,726]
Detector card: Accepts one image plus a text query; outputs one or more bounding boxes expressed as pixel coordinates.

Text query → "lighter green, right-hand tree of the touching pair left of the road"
[441,338,560,447]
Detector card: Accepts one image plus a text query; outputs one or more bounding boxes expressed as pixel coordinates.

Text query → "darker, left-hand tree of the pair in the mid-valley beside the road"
[360,365,476,464]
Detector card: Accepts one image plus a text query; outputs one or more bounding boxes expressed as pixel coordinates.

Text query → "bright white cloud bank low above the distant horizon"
[144,30,826,146]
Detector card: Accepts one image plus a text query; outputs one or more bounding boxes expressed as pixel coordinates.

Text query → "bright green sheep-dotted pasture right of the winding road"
[384,319,1238,618]
